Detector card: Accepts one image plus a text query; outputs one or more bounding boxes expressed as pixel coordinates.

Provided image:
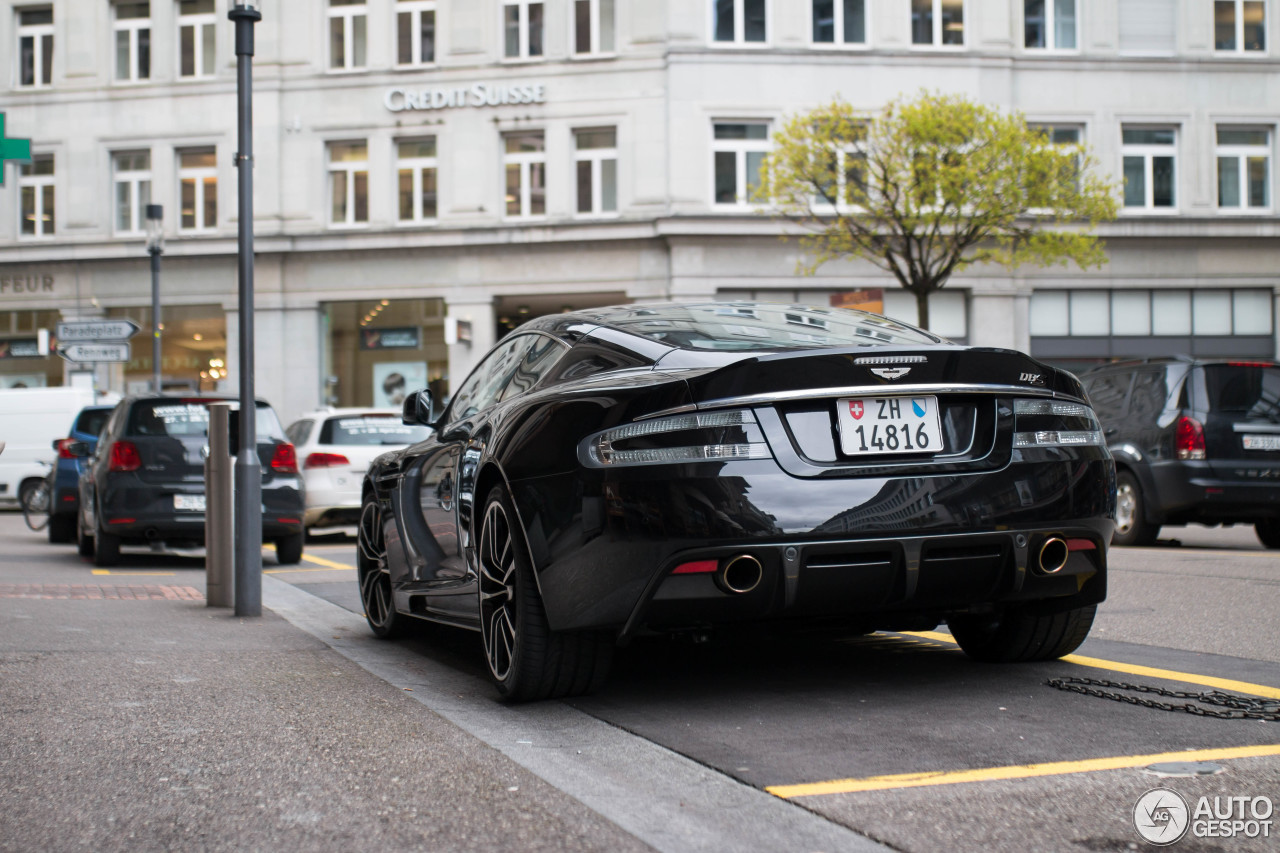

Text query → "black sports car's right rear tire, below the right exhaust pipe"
[947,605,1097,663]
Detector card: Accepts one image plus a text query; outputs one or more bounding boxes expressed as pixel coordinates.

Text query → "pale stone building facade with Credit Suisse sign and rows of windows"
[0,0,1280,420]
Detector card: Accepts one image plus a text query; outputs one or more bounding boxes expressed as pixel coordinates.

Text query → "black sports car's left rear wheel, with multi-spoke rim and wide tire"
[476,485,614,702]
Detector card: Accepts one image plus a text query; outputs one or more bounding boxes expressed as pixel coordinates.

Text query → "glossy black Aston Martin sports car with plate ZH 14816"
[358,302,1115,699]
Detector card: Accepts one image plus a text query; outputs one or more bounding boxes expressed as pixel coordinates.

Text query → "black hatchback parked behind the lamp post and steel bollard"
[76,394,305,566]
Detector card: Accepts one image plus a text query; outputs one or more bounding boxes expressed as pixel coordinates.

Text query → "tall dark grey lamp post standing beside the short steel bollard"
[227,0,262,616]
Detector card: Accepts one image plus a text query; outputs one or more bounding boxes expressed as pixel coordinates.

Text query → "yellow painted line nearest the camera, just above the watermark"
[764,744,1280,799]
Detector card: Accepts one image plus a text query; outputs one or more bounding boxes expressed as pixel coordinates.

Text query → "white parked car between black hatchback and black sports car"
[284,409,431,530]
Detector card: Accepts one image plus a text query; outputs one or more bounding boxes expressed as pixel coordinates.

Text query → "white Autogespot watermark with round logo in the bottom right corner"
[1133,788,1275,847]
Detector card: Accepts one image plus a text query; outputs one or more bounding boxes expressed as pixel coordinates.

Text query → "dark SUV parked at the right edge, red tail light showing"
[1080,357,1280,548]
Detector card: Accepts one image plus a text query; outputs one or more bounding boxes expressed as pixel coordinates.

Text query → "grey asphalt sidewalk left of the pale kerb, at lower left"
[0,532,648,853]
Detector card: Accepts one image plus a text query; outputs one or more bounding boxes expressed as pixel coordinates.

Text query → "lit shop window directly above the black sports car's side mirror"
[320,298,449,409]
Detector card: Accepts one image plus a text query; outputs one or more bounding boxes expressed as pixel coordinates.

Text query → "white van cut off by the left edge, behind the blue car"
[0,387,95,505]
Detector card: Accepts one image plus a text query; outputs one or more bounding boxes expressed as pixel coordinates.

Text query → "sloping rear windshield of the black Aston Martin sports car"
[588,302,938,352]
